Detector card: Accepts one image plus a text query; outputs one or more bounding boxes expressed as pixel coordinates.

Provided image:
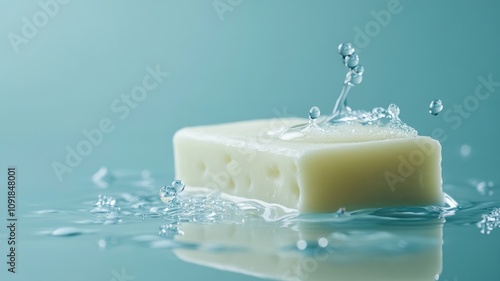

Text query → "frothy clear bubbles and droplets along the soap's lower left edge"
[88,176,296,229]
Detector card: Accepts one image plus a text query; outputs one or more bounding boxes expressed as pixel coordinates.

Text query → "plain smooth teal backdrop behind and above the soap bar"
[0,0,500,281]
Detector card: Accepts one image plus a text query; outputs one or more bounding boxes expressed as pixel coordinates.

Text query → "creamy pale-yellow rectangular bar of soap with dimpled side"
[173,118,444,212]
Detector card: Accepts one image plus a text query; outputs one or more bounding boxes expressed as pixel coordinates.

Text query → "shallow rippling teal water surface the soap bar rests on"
[10,173,500,280]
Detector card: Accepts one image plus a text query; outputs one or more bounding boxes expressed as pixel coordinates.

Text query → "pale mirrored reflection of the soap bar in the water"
[174,219,443,281]
